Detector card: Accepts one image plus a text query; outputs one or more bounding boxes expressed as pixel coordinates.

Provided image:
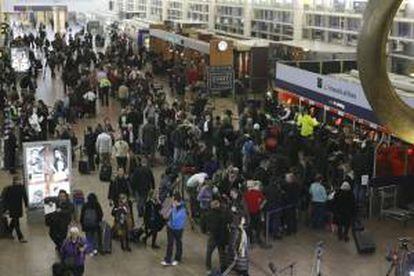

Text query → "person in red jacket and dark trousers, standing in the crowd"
[243,180,266,244]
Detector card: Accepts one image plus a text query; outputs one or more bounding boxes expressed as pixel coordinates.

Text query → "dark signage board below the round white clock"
[207,66,234,91]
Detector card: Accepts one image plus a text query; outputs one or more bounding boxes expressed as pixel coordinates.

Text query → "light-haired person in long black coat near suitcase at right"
[333,181,356,242]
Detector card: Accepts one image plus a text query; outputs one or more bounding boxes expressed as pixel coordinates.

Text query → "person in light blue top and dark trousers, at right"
[309,174,328,229]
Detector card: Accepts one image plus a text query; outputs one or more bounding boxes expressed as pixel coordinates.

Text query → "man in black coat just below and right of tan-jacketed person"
[131,157,155,224]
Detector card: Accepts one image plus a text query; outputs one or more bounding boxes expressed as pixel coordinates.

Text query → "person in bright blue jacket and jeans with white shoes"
[161,193,187,266]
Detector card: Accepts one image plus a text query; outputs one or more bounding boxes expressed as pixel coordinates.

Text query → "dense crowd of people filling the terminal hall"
[0,19,382,275]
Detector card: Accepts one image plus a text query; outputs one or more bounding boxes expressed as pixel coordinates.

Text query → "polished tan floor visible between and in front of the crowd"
[0,59,414,276]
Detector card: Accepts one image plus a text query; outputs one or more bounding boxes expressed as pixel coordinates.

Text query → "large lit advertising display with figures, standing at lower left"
[23,140,71,208]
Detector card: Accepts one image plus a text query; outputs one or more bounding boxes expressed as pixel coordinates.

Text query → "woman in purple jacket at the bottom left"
[60,226,86,276]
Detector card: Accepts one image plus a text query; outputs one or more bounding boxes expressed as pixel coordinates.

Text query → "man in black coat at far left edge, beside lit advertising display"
[5,176,27,243]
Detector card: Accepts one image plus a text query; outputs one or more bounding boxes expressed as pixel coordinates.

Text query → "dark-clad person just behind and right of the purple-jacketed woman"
[80,193,103,256]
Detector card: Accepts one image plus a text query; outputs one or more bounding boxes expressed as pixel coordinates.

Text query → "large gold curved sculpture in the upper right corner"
[358,0,414,143]
